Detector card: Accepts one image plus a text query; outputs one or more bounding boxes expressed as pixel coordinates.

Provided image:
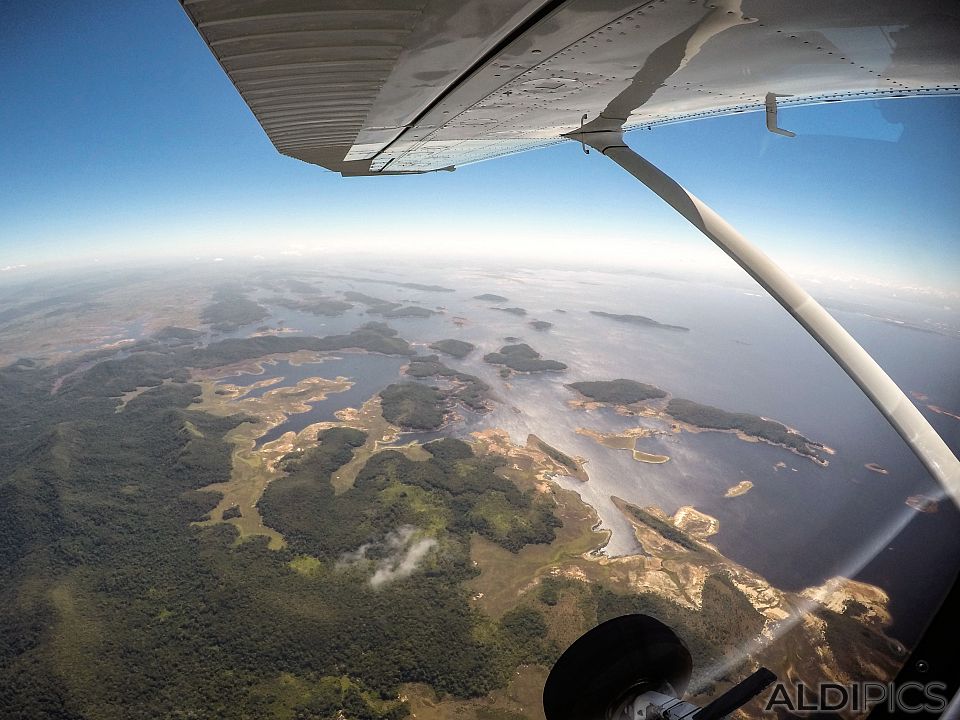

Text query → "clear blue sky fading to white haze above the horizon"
[0,0,960,291]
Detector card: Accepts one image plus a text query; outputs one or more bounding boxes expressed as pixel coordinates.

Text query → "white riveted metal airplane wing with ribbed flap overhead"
[181,0,960,175]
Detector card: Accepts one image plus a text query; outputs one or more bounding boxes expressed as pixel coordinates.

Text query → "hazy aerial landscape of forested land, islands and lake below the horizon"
[0,262,960,720]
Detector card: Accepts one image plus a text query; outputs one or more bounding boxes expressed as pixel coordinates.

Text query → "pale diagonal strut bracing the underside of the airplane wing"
[566,128,960,507]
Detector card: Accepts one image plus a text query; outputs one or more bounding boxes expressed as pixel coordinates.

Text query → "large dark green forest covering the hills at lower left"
[0,334,559,719]
